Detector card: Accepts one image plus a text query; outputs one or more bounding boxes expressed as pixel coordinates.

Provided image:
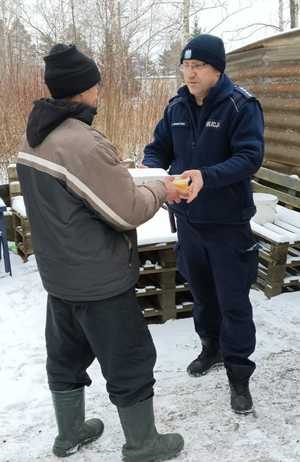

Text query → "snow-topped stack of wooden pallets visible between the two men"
[136,209,193,322]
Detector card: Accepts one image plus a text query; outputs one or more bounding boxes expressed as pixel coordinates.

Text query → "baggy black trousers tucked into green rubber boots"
[46,289,156,407]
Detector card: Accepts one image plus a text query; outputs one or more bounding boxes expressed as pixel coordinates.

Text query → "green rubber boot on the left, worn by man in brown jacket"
[51,388,104,457]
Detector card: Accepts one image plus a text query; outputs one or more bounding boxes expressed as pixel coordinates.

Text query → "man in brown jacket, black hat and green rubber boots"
[17,44,188,462]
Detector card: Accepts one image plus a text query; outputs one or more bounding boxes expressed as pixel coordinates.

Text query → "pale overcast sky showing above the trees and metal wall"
[24,0,289,55]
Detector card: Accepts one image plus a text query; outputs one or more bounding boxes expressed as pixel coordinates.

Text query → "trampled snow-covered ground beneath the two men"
[0,255,300,462]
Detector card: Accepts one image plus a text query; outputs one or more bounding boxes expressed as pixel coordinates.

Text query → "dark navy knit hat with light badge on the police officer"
[180,34,226,73]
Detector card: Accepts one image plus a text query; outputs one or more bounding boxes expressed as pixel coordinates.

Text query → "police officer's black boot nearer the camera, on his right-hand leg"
[226,365,255,414]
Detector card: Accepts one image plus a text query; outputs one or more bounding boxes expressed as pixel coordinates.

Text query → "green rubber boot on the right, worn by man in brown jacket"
[118,398,184,462]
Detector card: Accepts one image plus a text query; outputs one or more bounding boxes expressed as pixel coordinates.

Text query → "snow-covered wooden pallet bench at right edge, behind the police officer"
[251,167,300,297]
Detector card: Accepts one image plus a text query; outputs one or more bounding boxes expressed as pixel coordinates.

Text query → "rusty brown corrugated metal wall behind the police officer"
[226,30,300,175]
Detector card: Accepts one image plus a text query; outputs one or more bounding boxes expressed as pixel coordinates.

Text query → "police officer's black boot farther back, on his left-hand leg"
[187,338,223,377]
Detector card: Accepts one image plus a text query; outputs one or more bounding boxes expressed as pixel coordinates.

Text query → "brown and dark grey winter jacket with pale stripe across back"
[17,101,166,301]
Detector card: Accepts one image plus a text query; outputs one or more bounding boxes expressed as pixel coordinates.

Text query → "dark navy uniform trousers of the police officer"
[177,218,258,366]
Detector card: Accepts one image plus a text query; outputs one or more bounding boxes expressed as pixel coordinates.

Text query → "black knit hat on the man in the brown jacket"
[44,43,101,98]
